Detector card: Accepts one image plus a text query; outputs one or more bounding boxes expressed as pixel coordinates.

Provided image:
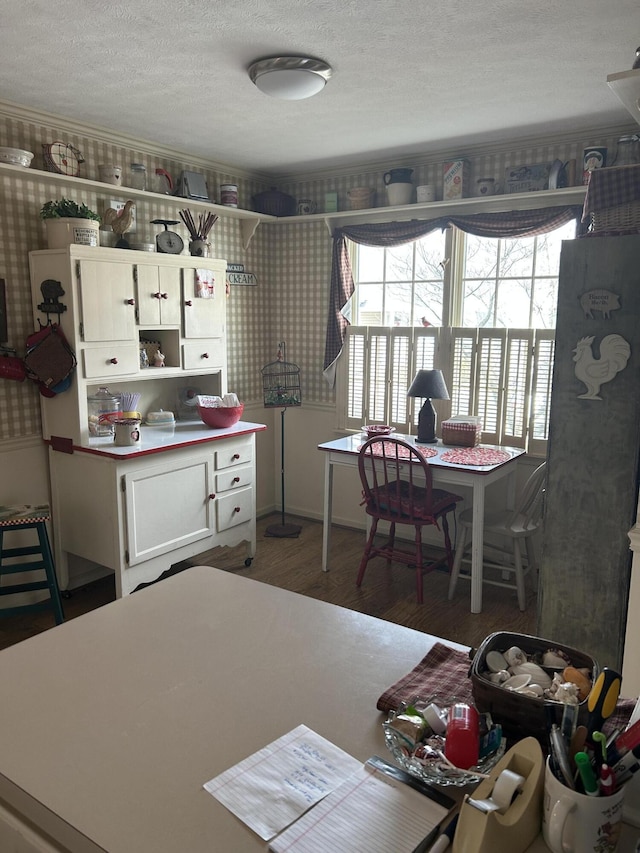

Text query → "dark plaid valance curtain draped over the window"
[323,206,582,388]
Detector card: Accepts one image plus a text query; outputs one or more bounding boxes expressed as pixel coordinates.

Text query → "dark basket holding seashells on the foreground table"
[471,632,599,746]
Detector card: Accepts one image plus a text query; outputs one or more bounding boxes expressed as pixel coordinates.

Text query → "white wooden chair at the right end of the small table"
[449,462,547,610]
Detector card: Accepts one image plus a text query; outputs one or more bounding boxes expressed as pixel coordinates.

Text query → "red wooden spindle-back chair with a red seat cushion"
[356,436,462,604]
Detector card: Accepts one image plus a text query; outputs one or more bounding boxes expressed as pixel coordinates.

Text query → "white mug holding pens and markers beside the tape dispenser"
[542,759,624,853]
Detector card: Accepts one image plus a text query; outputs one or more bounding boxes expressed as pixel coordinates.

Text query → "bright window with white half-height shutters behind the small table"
[338,223,575,455]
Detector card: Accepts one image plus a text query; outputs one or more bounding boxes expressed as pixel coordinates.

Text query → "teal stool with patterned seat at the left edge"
[0,504,64,625]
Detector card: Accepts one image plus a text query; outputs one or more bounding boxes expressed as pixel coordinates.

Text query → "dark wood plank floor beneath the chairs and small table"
[0,514,536,648]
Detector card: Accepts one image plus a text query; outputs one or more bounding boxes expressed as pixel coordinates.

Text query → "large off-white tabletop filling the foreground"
[0,567,632,853]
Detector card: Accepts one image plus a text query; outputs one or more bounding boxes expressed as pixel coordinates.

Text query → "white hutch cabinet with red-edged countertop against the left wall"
[29,245,265,597]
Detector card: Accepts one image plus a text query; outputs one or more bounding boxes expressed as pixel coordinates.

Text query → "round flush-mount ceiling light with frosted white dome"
[249,56,333,101]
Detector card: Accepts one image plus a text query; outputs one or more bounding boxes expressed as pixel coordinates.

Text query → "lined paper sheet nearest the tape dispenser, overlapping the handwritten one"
[269,765,449,853]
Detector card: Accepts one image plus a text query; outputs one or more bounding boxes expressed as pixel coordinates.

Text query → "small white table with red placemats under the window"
[318,433,525,613]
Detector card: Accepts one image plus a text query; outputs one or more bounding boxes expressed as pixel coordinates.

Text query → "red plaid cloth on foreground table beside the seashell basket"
[376,643,473,713]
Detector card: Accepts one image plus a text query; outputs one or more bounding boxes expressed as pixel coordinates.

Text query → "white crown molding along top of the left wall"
[0,100,270,181]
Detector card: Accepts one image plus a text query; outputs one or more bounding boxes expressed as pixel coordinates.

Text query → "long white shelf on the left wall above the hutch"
[0,163,277,249]
